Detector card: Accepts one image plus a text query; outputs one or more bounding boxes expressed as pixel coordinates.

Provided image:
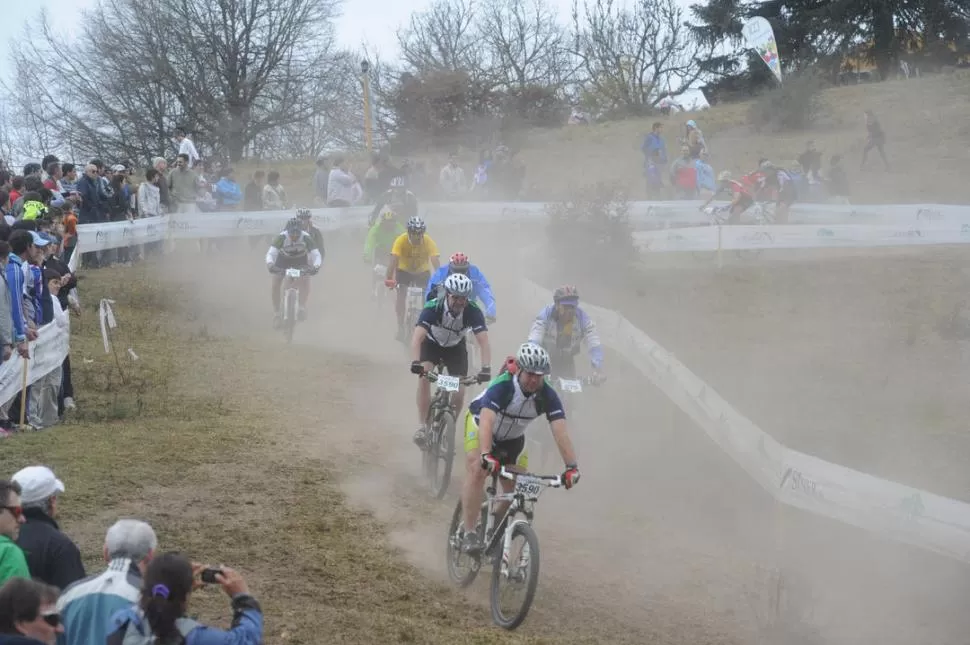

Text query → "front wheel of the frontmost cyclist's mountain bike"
[490,523,539,629]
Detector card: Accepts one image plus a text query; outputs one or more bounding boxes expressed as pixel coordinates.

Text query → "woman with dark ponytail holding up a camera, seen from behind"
[107,553,263,645]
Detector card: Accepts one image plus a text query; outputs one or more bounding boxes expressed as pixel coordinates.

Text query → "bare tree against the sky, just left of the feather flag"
[573,0,710,113]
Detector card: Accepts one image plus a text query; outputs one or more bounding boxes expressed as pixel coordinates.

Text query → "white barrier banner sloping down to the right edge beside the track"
[523,280,970,563]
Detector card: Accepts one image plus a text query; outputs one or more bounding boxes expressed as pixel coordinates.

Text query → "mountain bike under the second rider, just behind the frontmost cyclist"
[421,363,478,499]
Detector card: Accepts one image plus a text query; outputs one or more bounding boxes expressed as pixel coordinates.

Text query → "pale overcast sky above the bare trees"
[0,0,701,77]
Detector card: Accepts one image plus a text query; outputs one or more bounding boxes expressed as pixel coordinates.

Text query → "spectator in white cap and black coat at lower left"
[13,466,85,589]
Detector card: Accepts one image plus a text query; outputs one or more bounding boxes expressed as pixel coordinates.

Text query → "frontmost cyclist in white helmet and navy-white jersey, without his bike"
[461,342,579,553]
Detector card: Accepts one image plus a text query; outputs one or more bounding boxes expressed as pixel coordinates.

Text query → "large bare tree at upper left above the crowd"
[5,0,337,160]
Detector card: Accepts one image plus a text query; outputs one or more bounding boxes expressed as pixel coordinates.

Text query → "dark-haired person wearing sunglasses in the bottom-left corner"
[0,578,64,645]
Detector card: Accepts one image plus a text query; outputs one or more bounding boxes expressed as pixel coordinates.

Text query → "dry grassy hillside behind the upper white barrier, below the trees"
[244,72,970,203]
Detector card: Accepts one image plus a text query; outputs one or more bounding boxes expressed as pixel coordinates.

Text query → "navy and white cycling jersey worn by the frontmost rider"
[468,372,566,442]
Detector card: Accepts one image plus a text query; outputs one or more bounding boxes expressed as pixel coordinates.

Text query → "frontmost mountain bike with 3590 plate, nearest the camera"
[446,466,562,629]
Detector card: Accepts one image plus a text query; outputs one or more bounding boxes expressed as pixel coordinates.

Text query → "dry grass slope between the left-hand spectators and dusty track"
[0,265,591,645]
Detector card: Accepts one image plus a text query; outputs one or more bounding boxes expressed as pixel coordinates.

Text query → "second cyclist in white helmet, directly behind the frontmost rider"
[411,273,492,446]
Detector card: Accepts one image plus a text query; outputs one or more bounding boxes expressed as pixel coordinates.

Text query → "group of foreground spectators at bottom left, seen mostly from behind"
[0,466,263,645]
